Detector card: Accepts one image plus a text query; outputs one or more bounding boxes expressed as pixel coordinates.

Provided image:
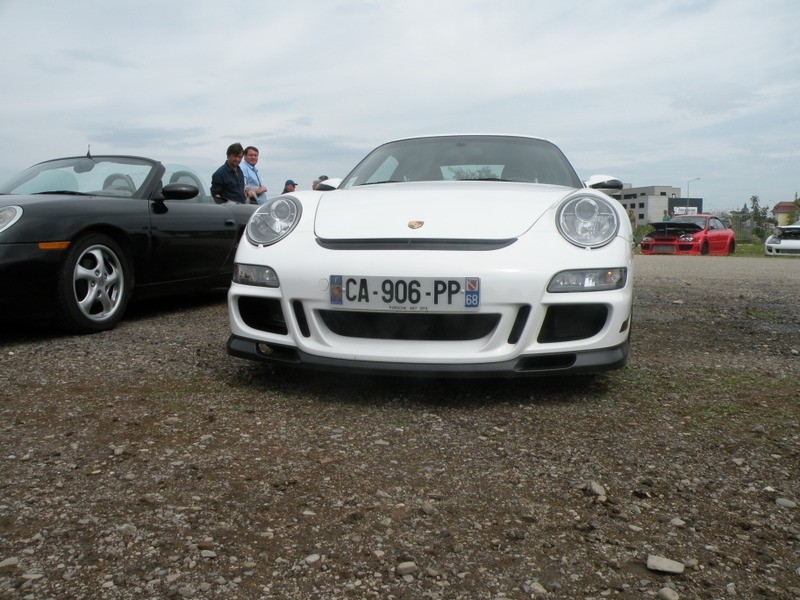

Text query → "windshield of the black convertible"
[0,156,159,198]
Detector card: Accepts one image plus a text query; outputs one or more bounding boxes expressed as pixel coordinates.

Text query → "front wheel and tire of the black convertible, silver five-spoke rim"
[56,233,133,333]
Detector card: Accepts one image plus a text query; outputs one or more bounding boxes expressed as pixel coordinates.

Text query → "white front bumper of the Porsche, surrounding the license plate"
[223,236,633,377]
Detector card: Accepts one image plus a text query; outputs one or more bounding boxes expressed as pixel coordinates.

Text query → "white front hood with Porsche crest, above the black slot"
[314,181,574,240]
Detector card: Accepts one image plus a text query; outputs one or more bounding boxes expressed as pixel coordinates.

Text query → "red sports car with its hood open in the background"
[641,215,736,255]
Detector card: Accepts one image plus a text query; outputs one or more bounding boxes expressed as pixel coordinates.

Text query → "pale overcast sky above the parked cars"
[0,0,800,210]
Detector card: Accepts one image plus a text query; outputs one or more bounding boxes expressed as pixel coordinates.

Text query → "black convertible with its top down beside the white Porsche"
[0,154,257,333]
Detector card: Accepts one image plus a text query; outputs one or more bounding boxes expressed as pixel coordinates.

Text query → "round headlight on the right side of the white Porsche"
[556,194,619,248]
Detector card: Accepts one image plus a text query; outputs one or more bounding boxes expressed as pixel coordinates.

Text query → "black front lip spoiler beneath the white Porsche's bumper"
[227,335,628,379]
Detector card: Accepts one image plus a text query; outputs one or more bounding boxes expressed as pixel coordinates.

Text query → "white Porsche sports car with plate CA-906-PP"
[228,135,633,377]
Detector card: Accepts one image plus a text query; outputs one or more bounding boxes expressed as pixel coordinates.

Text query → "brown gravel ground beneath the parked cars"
[0,256,800,600]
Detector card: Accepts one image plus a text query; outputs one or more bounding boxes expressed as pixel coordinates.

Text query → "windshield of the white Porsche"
[342,135,583,188]
